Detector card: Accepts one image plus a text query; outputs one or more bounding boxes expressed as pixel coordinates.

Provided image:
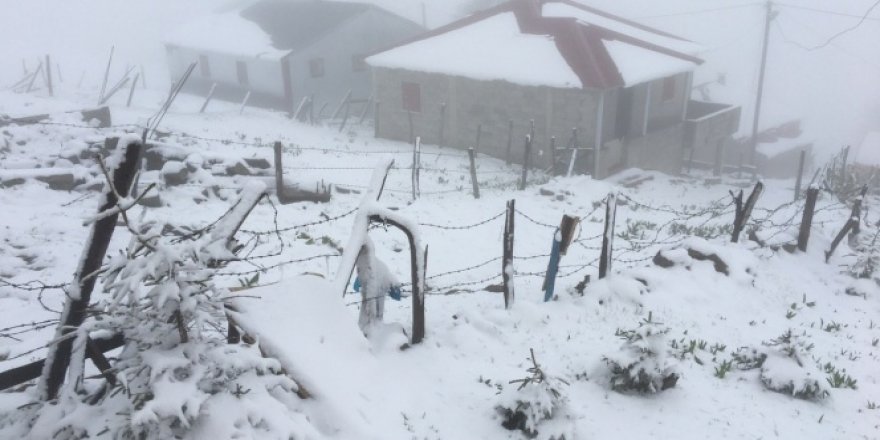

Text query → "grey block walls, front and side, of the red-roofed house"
[373,68,688,178]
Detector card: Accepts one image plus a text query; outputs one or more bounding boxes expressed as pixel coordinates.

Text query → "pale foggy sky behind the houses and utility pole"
[0,0,880,158]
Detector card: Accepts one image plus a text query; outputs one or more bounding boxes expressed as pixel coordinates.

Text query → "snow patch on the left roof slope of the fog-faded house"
[165,11,290,59]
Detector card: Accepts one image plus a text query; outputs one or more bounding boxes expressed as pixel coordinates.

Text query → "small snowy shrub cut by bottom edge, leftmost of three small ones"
[496,350,571,440]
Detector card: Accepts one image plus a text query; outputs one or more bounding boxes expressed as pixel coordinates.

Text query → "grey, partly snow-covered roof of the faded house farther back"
[165,0,375,58]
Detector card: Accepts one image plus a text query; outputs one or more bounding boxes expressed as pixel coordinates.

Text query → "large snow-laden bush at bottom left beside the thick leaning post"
[0,181,314,439]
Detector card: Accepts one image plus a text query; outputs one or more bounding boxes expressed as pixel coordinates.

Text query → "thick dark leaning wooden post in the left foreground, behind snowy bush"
[39,138,143,401]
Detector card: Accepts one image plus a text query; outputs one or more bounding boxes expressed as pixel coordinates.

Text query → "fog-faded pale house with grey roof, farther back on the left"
[165,0,424,111]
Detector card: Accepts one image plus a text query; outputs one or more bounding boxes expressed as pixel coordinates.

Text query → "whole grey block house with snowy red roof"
[367,0,738,178]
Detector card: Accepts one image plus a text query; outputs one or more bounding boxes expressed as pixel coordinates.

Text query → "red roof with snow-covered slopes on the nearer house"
[367,0,702,89]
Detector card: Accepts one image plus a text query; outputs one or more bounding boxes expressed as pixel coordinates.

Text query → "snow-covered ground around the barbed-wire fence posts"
[0,71,880,439]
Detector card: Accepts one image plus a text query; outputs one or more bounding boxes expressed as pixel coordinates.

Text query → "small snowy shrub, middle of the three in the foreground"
[603,313,679,394]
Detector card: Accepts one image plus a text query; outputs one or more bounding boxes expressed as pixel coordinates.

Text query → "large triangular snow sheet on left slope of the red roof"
[367,12,581,88]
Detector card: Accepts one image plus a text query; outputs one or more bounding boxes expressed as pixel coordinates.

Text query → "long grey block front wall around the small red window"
[373,68,613,168]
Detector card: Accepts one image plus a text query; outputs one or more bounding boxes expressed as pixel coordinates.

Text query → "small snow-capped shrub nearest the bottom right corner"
[761,329,828,400]
